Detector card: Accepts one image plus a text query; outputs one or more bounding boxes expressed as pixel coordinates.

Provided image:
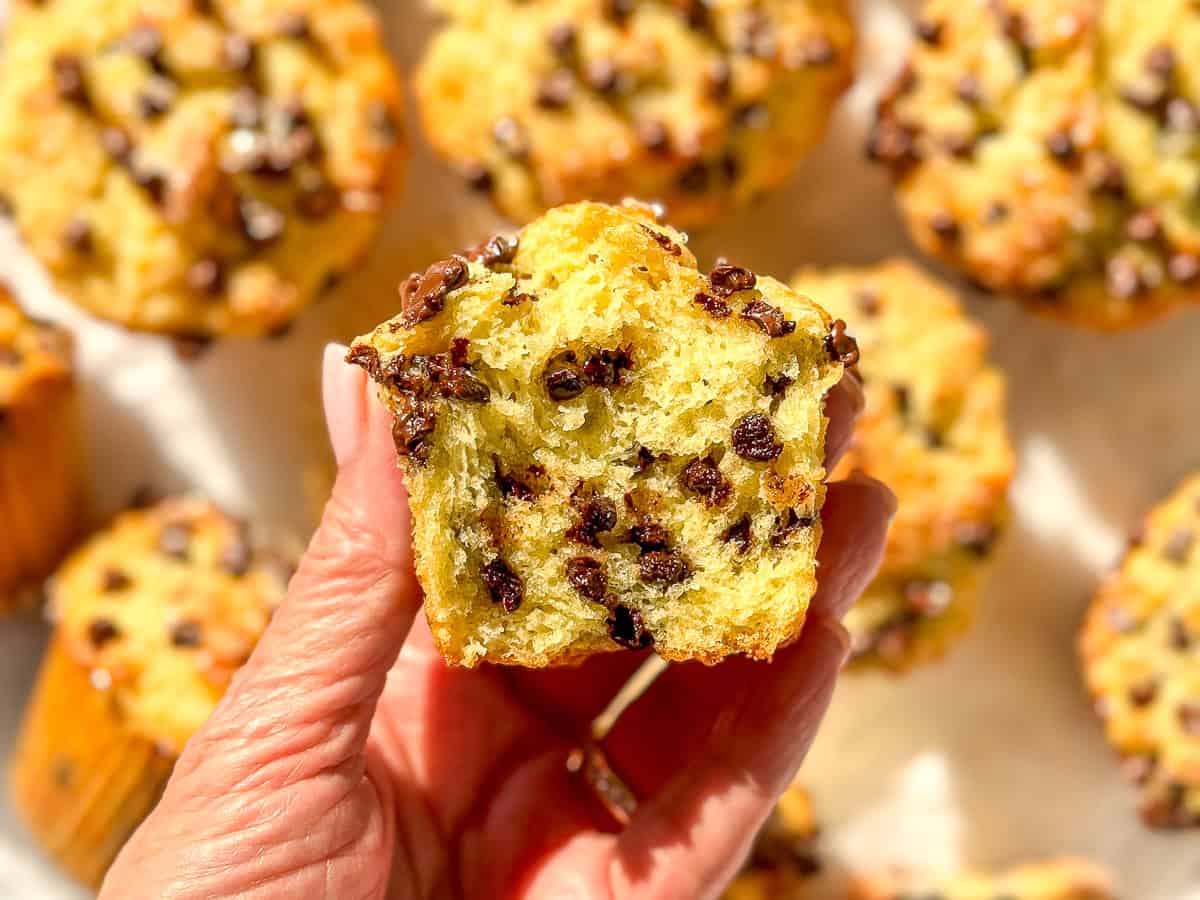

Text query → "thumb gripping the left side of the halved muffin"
[180,346,421,780]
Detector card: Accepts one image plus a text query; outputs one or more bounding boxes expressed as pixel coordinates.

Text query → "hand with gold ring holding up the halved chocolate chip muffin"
[101,347,895,900]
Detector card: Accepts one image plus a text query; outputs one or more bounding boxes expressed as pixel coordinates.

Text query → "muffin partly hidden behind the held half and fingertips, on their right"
[792,259,1013,670]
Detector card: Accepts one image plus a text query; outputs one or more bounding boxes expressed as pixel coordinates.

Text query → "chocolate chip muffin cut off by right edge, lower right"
[1080,475,1200,828]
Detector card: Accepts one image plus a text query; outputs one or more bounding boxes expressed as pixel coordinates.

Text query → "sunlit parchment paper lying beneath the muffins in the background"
[0,0,1200,900]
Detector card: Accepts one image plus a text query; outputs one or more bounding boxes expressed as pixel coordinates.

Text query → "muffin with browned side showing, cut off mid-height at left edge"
[0,283,86,612]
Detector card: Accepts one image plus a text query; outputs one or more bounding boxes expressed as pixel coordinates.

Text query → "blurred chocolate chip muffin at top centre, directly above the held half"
[416,0,854,228]
